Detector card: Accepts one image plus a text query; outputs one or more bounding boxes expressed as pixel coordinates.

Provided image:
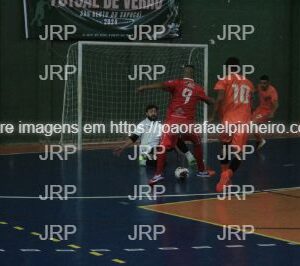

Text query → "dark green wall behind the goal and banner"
[0,0,300,143]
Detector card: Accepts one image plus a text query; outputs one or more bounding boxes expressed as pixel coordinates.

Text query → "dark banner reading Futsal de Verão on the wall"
[23,0,180,40]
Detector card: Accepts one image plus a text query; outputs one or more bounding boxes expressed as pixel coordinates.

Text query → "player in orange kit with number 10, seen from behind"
[212,57,254,192]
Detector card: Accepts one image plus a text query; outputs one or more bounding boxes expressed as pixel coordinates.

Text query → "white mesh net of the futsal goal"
[61,42,207,149]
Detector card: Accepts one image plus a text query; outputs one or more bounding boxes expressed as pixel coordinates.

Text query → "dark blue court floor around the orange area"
[0,138,300,266]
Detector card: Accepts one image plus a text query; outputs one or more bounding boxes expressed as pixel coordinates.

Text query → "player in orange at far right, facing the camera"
[252,75,278,150]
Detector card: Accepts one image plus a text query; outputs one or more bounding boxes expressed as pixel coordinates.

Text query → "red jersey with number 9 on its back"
[164,78,209,122]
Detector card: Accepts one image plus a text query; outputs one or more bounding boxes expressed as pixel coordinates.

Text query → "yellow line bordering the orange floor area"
[138,187,300,245]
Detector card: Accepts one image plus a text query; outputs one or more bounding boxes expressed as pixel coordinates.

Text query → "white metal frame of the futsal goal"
[62,41,208,154]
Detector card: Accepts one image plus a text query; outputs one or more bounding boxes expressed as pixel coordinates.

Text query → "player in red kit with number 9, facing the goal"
[138,65,213,185]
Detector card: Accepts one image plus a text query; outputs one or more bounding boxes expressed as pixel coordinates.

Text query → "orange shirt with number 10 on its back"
[215,74,254,123]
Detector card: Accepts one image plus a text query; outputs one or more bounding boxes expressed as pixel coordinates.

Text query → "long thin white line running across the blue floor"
[0,187,300,198]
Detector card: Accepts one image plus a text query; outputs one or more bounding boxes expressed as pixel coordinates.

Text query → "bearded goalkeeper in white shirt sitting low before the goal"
[114,104,196,166]
